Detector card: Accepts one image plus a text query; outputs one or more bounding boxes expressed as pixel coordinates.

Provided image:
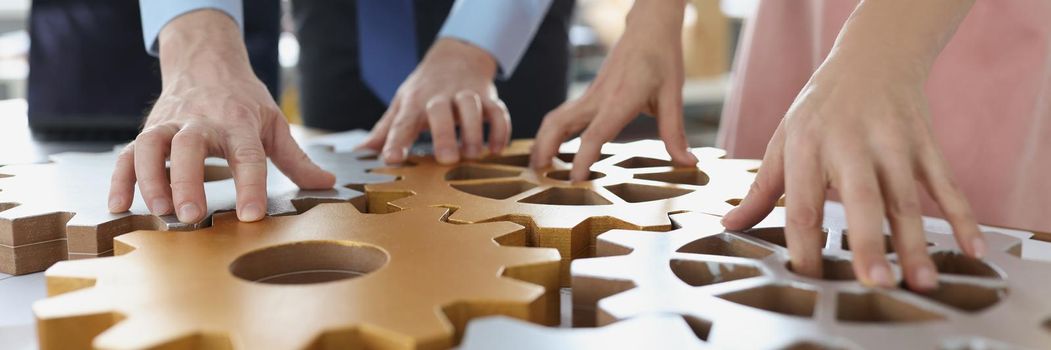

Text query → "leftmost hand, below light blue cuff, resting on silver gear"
[109,11,335,223]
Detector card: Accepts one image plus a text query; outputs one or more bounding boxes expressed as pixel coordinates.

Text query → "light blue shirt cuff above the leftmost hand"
[139,0,245,56]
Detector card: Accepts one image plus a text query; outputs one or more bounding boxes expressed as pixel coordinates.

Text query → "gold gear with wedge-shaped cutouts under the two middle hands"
[365,140,759,284]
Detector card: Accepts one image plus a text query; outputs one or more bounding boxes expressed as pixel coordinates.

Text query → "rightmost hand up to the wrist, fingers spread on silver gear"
[723,65,986,291]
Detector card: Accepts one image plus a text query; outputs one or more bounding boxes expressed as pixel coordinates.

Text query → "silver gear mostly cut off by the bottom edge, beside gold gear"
[460,314,710,350]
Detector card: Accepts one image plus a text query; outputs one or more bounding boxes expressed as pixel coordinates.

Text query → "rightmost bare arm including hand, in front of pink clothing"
[723,0,986,290]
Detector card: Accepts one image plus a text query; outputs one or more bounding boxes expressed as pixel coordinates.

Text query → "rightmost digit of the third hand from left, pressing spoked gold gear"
[657,84,697,166]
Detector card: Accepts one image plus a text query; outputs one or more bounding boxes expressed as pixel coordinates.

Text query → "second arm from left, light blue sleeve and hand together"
[360,0,552,164]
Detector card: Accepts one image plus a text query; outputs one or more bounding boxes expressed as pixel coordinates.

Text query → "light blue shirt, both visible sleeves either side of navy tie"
[139,0,553,78]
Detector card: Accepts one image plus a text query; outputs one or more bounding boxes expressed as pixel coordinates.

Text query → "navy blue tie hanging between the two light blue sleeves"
[357,0,418,105]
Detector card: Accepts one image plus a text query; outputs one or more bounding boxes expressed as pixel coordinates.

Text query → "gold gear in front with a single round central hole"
[34,203,559,349]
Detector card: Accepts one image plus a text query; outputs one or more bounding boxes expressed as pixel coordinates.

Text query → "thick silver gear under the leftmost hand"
[0,146,394,274]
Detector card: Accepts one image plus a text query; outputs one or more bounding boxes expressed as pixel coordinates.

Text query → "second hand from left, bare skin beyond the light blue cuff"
[359,38,511,164]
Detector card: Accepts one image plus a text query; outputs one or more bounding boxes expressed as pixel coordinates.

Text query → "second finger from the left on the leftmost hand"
[135,125,179,215]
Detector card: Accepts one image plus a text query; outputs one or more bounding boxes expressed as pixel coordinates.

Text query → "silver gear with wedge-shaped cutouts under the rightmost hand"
[572,213,1051,349]
